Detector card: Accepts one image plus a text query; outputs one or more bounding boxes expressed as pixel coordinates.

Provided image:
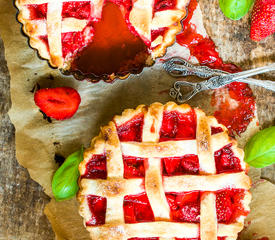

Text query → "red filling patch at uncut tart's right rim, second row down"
[214,144,242,173]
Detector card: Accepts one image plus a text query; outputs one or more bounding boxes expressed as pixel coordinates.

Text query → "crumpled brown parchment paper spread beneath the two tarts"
[0,0,275,240]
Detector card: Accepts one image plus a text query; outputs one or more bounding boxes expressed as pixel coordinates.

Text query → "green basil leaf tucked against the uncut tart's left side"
[52,147,83,201]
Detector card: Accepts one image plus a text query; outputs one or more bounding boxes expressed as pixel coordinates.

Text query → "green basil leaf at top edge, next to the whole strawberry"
[219,0,254,20]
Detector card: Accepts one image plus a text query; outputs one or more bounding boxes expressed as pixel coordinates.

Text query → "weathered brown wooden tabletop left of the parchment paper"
[0,36,54,240]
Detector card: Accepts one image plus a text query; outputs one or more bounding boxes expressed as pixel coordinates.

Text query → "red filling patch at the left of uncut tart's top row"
[117,114,144,142]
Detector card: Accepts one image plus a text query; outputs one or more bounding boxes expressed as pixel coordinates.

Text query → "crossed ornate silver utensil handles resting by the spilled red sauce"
[163,57,275,103]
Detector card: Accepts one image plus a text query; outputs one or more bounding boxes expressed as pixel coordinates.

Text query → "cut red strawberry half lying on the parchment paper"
[34,87,81,120]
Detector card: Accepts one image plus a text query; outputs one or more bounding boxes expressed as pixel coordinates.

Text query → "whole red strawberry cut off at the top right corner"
[250,0,275,41]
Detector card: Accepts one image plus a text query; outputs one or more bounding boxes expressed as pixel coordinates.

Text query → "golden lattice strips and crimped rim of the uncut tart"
[79,102,251,240]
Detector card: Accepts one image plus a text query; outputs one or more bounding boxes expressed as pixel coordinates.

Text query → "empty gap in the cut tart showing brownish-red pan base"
[72,2,149,77]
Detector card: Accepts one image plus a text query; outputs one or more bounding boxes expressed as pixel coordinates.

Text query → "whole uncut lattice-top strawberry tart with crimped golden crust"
[78,102,251,240]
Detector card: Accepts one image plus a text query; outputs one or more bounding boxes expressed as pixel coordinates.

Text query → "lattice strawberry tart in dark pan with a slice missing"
[16,0,189,79]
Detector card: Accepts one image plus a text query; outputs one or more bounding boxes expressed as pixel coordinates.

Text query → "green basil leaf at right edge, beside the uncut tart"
[244,126,275,168]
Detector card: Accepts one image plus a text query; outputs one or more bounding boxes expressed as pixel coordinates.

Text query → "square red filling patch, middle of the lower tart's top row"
[159,110,196,142]
